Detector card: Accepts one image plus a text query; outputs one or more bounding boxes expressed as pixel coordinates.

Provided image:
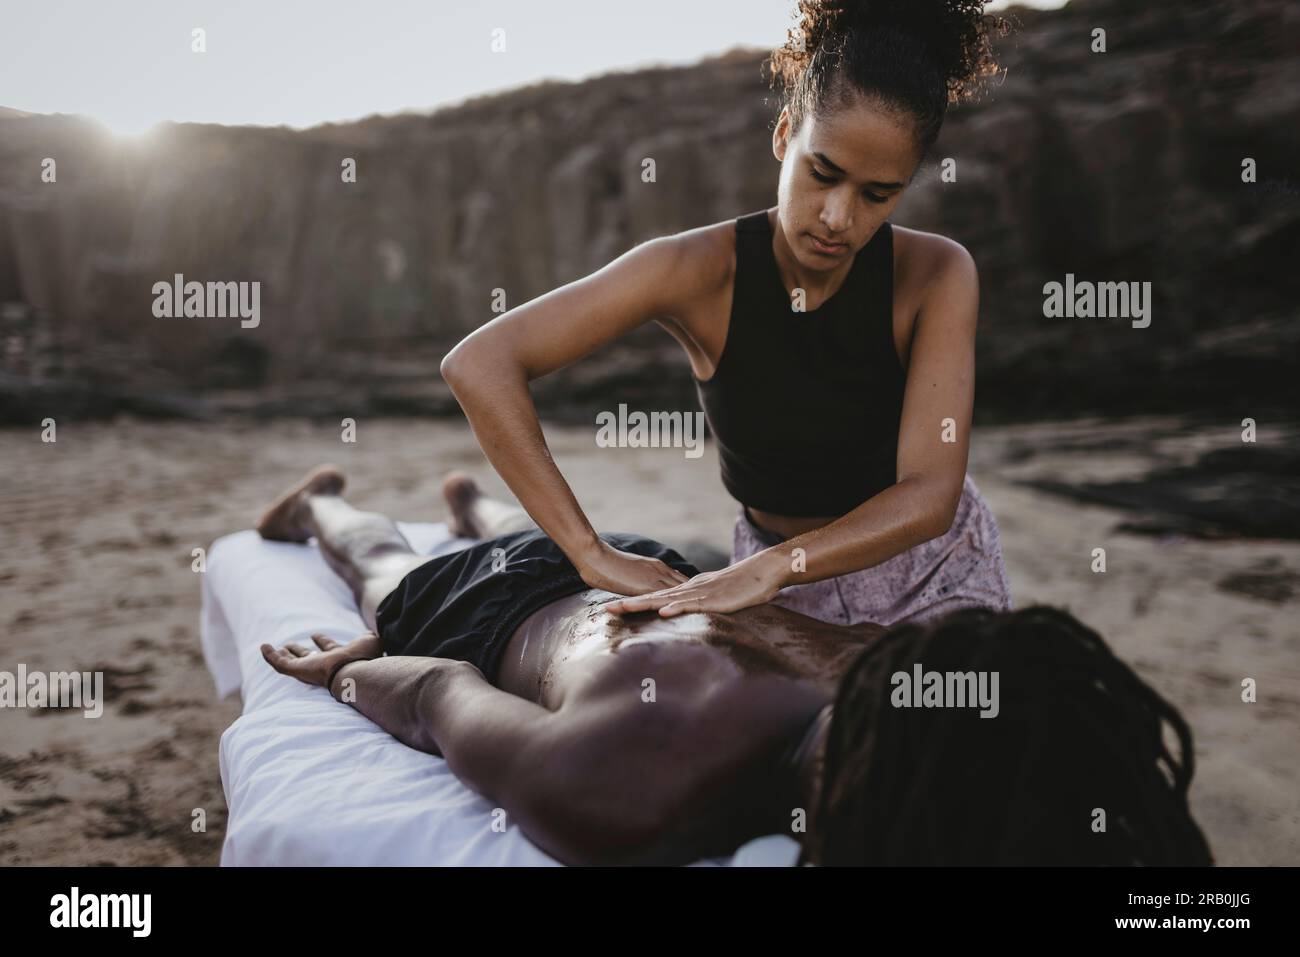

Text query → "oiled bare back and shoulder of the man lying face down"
[495,589,883,863]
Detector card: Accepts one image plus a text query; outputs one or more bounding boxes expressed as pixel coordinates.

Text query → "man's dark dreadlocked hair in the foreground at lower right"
[800,606,1213,865]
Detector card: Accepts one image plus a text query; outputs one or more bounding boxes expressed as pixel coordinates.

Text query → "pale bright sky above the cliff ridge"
[0,0,1065,134]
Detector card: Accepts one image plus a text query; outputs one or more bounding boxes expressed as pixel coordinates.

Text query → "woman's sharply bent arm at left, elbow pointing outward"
[442,234,705,594]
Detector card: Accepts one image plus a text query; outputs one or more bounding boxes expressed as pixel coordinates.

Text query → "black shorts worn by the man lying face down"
[374,528,699,684]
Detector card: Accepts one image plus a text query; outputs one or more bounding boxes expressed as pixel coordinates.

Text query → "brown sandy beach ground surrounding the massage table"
[0,419,1300,865]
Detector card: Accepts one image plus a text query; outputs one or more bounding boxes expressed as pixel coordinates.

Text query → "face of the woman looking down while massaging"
[772,99,920,270]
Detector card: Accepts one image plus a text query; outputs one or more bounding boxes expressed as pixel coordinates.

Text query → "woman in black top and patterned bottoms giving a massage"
[442,0,1010,625]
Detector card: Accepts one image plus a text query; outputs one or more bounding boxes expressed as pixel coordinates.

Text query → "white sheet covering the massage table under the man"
[200,523,798,866]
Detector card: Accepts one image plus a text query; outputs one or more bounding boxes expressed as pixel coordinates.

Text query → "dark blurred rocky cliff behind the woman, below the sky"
[0,0,1300,421]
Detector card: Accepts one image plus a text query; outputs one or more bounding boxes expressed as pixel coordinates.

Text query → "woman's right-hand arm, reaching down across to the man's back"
[602,239,979,616]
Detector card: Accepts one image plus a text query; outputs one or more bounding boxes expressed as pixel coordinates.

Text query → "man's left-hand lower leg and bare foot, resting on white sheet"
[257,465,429,631]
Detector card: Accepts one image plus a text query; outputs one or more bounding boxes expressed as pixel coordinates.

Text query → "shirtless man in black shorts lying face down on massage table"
[257,467,1212,865]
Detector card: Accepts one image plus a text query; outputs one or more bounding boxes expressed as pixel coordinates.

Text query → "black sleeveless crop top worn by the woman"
[696,209,906,516]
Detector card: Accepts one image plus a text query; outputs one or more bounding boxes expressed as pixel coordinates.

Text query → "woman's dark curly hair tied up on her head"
[767,0,1010,152]
